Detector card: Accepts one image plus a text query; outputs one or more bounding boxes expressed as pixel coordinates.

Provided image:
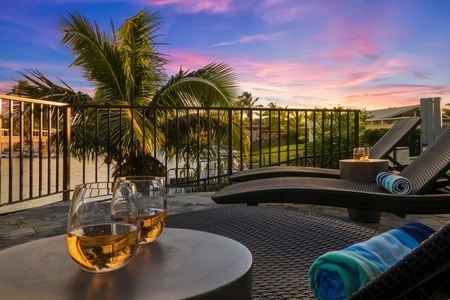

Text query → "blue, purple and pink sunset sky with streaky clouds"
[0,0,450,110]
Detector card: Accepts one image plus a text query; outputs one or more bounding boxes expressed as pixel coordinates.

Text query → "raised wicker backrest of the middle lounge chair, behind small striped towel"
[399,127,450,192]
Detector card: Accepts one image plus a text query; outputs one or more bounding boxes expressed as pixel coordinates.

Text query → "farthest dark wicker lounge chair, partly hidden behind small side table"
[228,117,421,183]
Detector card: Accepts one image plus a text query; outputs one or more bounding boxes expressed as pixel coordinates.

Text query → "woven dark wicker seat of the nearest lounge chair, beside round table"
[167,205,379,299]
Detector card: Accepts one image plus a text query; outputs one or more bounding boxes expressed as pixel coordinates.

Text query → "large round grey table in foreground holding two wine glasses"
[0,228,252,300]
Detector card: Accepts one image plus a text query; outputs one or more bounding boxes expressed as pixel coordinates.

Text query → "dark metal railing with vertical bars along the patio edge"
[0,95,359,205]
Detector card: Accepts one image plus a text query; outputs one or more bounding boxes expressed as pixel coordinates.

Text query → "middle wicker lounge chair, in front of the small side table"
[212,128,450,216]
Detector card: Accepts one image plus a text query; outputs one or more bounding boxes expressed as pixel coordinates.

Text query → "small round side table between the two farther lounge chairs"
[339,159,389,223]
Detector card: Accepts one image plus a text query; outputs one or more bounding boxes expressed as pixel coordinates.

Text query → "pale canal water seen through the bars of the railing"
[0,150,239,214]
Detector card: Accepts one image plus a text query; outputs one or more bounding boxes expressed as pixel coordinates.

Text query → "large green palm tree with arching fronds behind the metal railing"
[9,10,237,176]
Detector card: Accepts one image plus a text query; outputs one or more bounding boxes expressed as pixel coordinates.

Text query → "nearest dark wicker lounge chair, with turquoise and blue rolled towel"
[166,205,450,300]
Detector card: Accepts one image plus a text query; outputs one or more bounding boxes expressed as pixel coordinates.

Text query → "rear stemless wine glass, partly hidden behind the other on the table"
[117,176,167,244]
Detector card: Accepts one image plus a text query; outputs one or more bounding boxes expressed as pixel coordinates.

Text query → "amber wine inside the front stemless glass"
[67,223,139,272]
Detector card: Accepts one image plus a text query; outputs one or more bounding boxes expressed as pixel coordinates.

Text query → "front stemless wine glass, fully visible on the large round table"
[67,182,140,273]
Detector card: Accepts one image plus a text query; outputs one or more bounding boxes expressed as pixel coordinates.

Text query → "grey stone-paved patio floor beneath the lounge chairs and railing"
[0,192,450,250]
